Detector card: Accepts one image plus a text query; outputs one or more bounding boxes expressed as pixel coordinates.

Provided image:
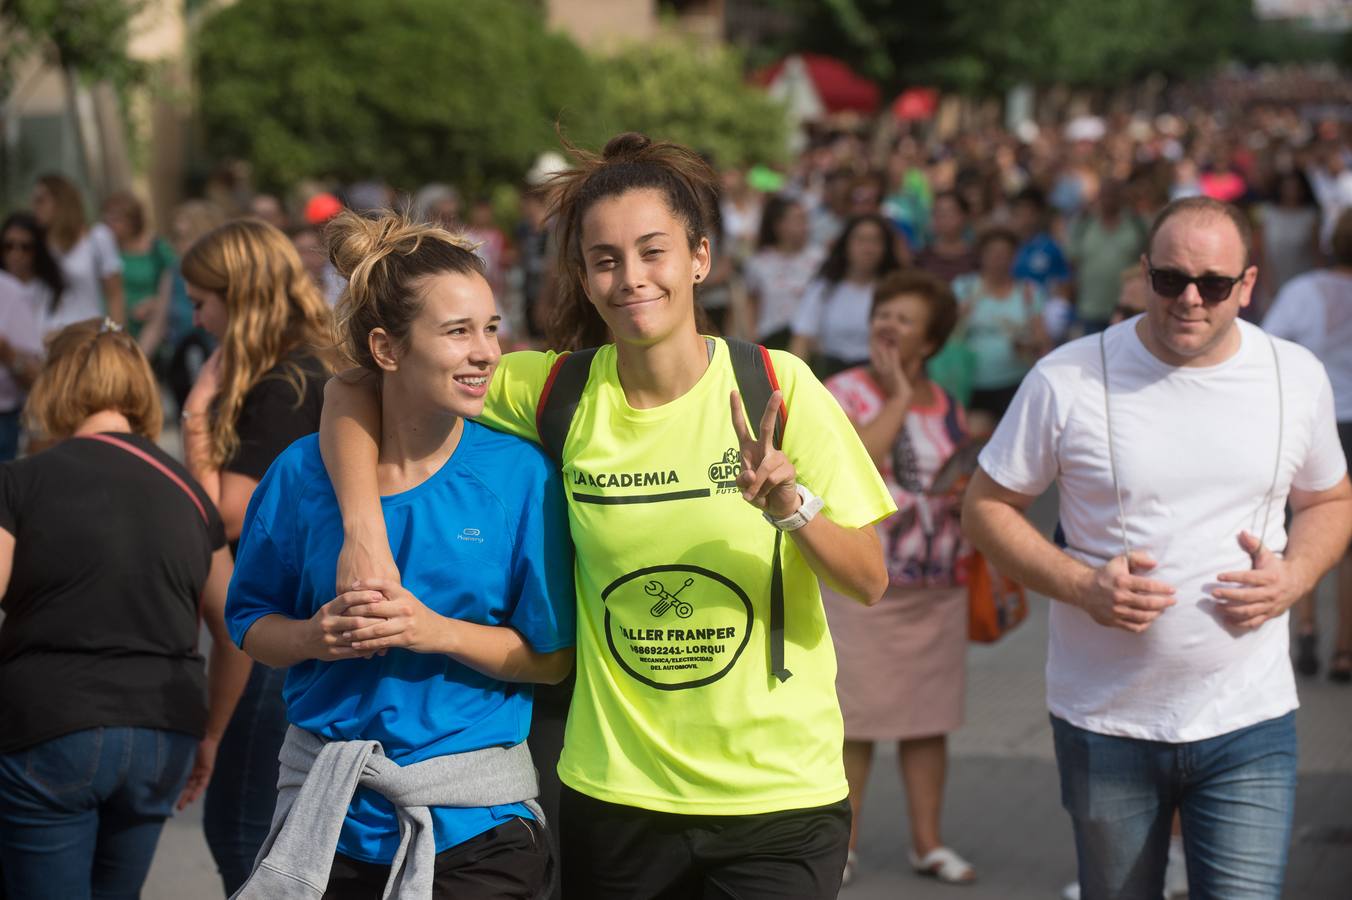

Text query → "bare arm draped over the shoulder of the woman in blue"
[319,369,400,589]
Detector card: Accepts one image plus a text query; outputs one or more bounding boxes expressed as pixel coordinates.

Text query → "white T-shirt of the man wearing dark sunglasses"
[980,316,1347,743]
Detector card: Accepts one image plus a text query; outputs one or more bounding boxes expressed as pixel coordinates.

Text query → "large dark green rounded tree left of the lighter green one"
[195,0,602,189]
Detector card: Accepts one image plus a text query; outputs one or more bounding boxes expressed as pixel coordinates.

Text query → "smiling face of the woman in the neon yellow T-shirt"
[581,188,710,346]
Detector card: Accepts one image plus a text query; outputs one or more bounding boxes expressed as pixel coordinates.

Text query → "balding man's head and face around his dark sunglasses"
[1137,212,1257,366]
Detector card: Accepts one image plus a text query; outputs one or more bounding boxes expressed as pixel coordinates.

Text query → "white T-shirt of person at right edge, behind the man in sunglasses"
[1263,269,1352,422]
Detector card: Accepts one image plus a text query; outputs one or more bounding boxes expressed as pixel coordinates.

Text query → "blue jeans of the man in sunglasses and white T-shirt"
[1052,712,1297,900]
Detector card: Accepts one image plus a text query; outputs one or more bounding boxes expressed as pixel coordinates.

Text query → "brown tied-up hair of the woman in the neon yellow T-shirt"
[548,131,718,350]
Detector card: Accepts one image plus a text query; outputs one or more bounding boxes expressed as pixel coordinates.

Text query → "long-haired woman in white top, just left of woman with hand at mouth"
[788,214,900,378]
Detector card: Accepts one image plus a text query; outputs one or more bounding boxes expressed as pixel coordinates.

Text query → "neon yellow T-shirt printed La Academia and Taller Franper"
[481,341,896,815]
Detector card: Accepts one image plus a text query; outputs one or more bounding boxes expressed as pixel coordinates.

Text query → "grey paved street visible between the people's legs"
[145,486,1352,900]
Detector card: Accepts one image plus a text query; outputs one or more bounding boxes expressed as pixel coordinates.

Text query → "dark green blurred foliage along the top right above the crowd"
[773,0,1334,93]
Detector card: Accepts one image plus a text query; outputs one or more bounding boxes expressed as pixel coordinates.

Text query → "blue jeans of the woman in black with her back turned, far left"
[0,728,197,900]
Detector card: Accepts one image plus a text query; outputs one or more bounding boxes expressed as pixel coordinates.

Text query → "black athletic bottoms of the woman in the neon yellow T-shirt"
[558,785,850,900]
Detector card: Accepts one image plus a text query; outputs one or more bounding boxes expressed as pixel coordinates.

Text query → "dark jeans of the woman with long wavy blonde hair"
[201,662,287,897]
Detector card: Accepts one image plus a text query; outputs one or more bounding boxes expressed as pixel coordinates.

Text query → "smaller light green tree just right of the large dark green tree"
[599,38,788,165]
